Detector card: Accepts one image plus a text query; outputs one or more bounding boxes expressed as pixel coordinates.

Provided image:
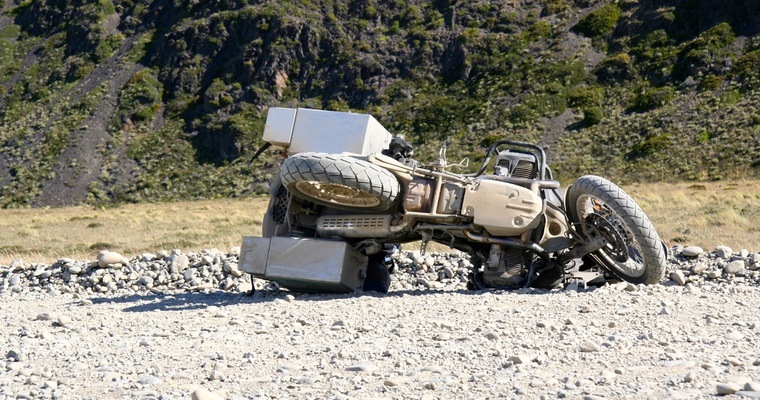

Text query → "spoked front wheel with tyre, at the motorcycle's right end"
[566,175,667,284]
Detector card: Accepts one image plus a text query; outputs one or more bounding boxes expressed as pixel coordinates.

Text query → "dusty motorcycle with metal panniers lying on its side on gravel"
[239,108,667,292]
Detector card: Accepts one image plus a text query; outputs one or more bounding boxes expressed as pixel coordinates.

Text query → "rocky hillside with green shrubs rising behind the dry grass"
[0,0,760,207]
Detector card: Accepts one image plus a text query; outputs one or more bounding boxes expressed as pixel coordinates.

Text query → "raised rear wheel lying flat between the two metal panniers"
[280,153,400,211]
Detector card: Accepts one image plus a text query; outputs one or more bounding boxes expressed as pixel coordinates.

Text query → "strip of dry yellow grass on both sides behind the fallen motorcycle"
[0,181,760,265]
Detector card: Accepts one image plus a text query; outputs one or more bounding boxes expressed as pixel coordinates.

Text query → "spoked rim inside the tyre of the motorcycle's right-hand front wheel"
[576,195,646,278]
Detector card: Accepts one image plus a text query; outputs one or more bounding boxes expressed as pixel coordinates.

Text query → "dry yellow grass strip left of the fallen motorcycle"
[0,198,268,265]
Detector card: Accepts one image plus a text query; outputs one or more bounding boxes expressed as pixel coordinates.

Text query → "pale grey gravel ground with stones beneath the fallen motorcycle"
[0,244,760,399]
